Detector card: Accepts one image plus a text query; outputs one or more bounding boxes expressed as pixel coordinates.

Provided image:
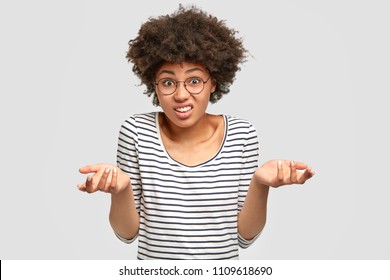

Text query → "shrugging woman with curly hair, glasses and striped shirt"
[78,6,314,259]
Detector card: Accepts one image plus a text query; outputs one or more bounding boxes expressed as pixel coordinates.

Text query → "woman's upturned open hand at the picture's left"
[77,163,131,194]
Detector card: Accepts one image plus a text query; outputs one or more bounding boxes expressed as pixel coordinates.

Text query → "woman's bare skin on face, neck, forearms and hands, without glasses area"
[78,62,314,240]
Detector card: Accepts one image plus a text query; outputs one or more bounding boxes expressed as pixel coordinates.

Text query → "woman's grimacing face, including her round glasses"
[156,62,215,128]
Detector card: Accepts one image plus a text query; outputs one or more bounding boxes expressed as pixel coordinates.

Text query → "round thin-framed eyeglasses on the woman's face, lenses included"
[156,75,211,95]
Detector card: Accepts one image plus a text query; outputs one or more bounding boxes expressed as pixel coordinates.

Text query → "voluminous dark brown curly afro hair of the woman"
[126,5,247,106]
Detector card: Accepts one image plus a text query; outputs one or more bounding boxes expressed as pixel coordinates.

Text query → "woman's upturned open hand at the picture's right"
[254,160,315,188]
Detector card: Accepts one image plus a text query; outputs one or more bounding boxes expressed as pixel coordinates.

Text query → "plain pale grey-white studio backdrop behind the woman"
[0,0,390,260]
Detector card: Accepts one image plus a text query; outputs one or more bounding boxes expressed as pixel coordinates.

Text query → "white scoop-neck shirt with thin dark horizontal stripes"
[116,112,258,259]
